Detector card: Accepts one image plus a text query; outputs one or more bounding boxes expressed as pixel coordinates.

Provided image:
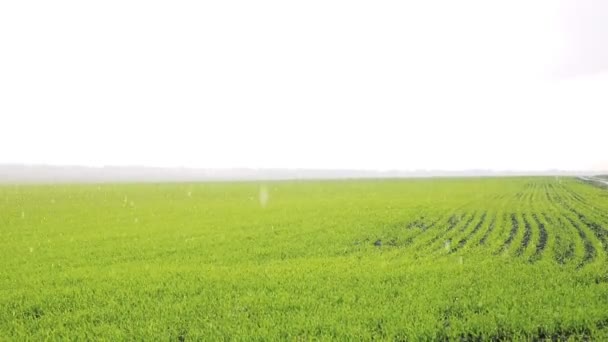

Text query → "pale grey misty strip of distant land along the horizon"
[0,165,608,183]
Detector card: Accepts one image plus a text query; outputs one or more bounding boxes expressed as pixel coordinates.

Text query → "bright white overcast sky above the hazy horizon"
[0,0,608,170]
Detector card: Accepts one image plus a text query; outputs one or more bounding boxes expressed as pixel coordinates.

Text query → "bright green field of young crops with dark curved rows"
[0,177,608,341]
